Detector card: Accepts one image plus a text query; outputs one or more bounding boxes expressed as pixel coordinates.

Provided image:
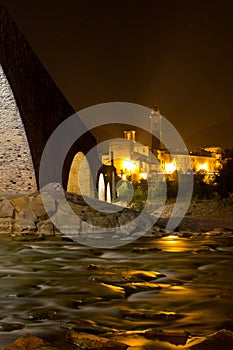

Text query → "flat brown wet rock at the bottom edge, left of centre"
[66,331,128,350]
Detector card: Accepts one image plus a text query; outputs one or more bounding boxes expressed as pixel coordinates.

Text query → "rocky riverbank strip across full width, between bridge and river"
[0,184,233,239]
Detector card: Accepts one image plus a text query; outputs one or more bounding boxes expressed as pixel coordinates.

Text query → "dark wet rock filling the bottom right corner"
[189,329,233,350]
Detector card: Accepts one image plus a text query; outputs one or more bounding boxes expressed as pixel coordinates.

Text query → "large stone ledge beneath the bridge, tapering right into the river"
[0,184,157,241]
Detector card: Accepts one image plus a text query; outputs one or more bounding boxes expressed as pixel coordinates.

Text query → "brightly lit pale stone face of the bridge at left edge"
[0,66,36,193]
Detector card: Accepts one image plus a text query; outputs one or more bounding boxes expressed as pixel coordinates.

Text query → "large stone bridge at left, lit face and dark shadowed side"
[0,0,96,194]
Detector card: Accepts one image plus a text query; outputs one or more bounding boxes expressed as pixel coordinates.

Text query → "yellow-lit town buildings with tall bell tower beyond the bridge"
[102,107,222,181]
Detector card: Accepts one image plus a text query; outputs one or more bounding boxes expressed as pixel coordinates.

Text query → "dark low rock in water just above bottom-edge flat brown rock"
[61,320,114,335]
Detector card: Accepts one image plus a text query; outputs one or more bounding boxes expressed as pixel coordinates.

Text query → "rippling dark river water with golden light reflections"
[0,234,233,350]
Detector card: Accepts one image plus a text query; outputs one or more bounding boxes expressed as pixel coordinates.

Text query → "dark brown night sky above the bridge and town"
[5,0,233,146]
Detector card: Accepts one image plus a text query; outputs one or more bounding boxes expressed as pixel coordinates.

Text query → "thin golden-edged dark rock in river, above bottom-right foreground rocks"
[124,310,186,321]
